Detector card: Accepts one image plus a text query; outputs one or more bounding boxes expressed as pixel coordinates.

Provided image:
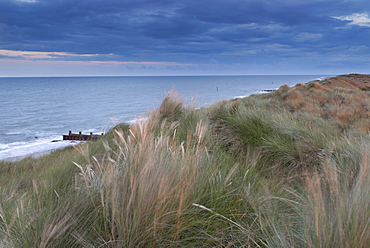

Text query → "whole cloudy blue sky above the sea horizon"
[0,0,370,77]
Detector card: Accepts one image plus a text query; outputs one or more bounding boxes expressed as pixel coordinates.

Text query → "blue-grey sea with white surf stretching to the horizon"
[0,75,330,160]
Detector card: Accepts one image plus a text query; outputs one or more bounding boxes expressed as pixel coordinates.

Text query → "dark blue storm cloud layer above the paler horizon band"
[0,0,370,73]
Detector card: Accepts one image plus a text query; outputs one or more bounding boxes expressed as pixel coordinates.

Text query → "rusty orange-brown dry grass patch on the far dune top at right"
[270,75,370,133]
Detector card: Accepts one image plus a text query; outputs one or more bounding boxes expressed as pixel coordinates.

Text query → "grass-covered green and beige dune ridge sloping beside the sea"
[0,74,370,247]
